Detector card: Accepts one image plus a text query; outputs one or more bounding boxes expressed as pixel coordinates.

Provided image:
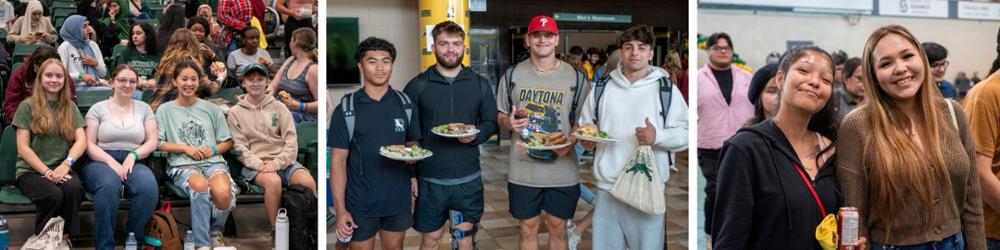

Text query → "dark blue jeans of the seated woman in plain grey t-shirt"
[80,150,160,249]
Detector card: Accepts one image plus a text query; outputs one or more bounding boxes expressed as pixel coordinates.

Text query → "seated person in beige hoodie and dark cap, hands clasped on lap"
[226,64,316,227]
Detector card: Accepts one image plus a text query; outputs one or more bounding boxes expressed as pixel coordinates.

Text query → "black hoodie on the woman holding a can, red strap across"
[712,120,843,250]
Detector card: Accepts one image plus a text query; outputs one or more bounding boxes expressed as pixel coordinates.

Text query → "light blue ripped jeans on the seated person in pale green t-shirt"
[167,164,239,247]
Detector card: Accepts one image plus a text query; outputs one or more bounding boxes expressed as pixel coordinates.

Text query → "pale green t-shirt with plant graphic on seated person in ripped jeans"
[156,99,232,167]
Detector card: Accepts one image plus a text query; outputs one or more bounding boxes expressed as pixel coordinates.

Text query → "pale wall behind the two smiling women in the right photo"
[695,9,1000,81]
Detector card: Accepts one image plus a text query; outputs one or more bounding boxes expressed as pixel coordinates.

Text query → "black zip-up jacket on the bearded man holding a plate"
[403,66,498,179]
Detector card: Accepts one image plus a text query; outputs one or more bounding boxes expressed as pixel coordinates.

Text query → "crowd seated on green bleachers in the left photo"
[0,0,318,249]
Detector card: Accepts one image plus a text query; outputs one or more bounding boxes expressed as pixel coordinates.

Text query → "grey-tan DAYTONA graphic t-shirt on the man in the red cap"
[497,60,590,187]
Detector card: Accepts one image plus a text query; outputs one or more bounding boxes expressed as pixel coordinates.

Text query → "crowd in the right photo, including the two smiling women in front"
[698,25,1000,249]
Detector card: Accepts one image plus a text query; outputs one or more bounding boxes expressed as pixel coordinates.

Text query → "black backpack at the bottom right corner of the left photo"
[281,184,318,249]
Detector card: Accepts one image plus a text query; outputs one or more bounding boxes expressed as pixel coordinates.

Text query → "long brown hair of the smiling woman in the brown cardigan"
[858,25,958,229]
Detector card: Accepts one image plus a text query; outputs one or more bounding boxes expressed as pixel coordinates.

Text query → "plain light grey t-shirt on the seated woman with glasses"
[87,100,156,151]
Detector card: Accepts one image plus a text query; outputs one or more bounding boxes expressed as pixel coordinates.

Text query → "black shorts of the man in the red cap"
[507,182,580,220]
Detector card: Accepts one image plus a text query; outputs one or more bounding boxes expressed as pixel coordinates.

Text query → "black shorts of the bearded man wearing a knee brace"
[413,177,483,233]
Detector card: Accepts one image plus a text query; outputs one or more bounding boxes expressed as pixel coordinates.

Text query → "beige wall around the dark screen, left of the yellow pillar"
[327,0,421,114]
